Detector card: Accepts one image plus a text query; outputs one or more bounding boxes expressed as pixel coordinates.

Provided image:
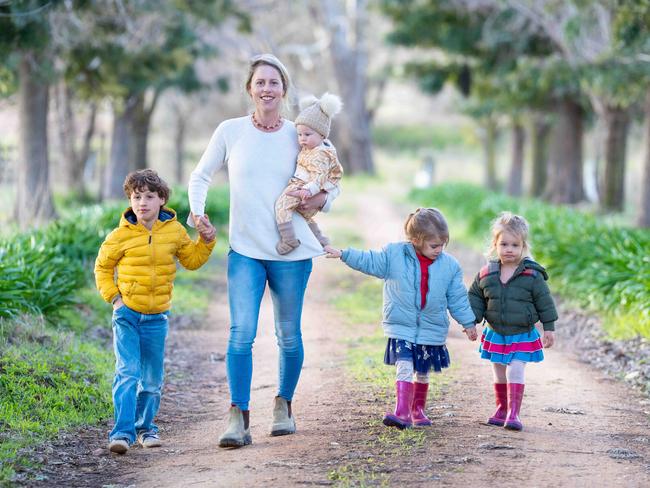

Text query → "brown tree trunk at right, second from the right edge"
[601,104,630,212]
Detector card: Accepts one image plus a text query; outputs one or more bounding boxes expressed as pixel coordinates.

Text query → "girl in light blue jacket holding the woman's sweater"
[328,208,477,429]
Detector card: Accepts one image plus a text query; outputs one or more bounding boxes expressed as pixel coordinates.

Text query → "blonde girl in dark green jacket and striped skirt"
[469,212,557,430]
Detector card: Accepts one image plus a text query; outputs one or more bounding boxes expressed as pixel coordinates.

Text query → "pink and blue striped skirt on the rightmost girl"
[478,327,544,364]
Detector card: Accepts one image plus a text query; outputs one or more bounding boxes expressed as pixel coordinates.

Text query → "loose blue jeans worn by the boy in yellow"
[109,306,168,443]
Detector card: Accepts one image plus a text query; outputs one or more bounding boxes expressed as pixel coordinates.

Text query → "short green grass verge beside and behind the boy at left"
[0,260,223,486]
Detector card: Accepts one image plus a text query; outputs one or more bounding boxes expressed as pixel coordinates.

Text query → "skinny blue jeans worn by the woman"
[226,250,312,410]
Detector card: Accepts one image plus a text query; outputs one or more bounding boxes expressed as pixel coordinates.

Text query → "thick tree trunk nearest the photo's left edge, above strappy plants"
[14,51,56,229]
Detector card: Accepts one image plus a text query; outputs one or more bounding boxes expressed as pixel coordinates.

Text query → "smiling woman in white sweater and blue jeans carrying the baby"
[189,54,337,447]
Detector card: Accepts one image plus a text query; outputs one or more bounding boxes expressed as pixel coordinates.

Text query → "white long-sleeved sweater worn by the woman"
[188,116,338,261]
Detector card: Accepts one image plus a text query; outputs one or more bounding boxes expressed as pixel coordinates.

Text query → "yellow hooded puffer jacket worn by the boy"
[95,208,216,314]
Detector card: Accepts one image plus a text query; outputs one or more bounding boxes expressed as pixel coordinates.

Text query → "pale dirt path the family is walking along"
[26,179,650,488]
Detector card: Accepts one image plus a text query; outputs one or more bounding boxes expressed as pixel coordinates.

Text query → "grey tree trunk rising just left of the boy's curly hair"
[102,97,137,199]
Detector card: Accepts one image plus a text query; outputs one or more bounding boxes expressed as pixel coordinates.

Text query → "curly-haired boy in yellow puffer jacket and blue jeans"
[95,169,216,454]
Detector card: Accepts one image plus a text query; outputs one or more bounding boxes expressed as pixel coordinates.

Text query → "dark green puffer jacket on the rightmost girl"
[469,258,557,335]
